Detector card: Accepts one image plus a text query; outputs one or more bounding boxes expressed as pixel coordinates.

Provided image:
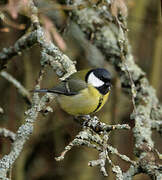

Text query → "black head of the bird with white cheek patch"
[85,68,111,95]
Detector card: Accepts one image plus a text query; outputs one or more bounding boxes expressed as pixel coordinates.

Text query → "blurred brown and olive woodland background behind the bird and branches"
[0,0,162,180]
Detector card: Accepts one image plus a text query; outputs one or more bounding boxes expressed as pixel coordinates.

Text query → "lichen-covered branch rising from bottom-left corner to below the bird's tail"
[0,73,39,179]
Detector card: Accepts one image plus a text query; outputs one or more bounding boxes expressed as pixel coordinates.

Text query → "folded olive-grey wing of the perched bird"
[48,79,87,96]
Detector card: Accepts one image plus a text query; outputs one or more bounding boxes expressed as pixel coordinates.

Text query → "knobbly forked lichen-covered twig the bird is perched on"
[55,116,132,180]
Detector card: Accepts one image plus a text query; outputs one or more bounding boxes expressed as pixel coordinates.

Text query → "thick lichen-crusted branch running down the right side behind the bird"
[67,0,162,179]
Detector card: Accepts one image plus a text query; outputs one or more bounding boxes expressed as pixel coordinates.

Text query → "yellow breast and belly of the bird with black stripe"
[58,85,109,115]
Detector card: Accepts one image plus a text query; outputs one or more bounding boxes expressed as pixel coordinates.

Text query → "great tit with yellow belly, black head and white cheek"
[34,68,111,116]
